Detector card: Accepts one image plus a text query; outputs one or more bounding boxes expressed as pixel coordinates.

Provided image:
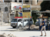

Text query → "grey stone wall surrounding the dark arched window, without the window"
[0,3,10,22]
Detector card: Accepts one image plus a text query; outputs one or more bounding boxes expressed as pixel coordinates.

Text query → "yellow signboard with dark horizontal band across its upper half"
[23,5,31,18]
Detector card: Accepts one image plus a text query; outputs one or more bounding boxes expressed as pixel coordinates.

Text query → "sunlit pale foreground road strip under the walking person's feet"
[0,31,50,37]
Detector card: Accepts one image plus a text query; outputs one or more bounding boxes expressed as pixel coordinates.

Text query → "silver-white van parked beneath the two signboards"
[11,18,33,28]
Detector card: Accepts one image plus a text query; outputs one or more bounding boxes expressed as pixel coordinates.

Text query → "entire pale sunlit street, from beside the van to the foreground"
[0,26,50,37]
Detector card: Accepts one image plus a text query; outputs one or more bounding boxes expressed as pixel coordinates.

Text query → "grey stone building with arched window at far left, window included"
[0,2,11,22]
